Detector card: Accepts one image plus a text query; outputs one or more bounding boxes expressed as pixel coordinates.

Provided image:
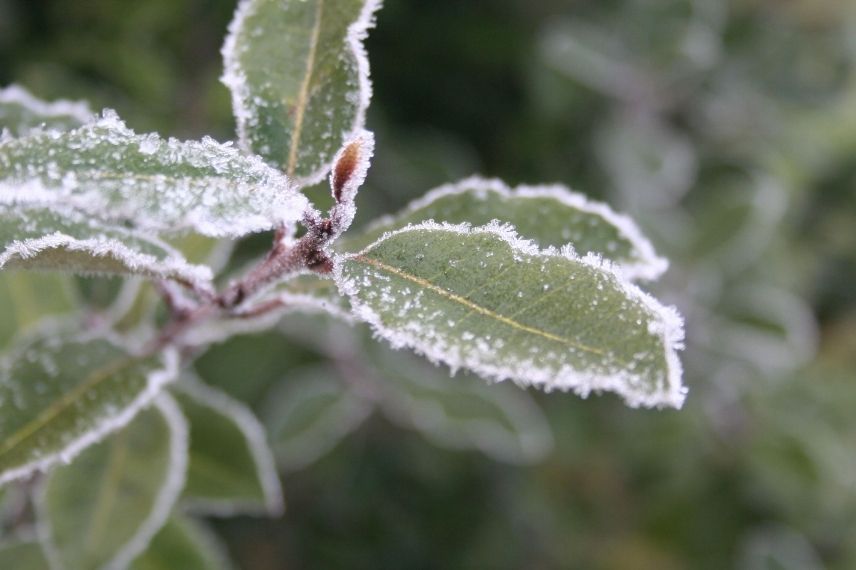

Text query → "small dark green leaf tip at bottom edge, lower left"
[131,514,233,570]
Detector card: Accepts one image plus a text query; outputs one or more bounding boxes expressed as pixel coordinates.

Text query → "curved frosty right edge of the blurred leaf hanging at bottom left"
[103,393,190,570]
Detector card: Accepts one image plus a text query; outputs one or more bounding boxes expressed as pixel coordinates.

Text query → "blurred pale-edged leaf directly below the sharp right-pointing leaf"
[375,350,553,464]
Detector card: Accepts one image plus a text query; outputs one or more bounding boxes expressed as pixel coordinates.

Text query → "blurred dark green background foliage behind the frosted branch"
[0,0,856,570]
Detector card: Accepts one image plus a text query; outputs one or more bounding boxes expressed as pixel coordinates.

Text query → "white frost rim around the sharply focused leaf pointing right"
[333,221,687,409]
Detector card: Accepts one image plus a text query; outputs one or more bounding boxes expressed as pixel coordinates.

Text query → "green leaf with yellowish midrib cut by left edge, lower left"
[0,325,178,483]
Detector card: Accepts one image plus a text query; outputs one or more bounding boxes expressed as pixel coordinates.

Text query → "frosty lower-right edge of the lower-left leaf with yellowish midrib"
[0,332,179,485]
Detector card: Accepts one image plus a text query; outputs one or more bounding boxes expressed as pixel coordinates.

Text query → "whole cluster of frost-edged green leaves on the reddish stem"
[0,0,685,569]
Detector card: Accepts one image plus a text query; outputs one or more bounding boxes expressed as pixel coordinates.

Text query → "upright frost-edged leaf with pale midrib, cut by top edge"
[222,0,380,186]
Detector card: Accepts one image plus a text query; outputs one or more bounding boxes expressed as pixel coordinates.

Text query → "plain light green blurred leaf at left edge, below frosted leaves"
[0,270,79,349]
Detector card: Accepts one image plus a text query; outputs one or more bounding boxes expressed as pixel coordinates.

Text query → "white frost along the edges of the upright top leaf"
[220,0,383,188]
